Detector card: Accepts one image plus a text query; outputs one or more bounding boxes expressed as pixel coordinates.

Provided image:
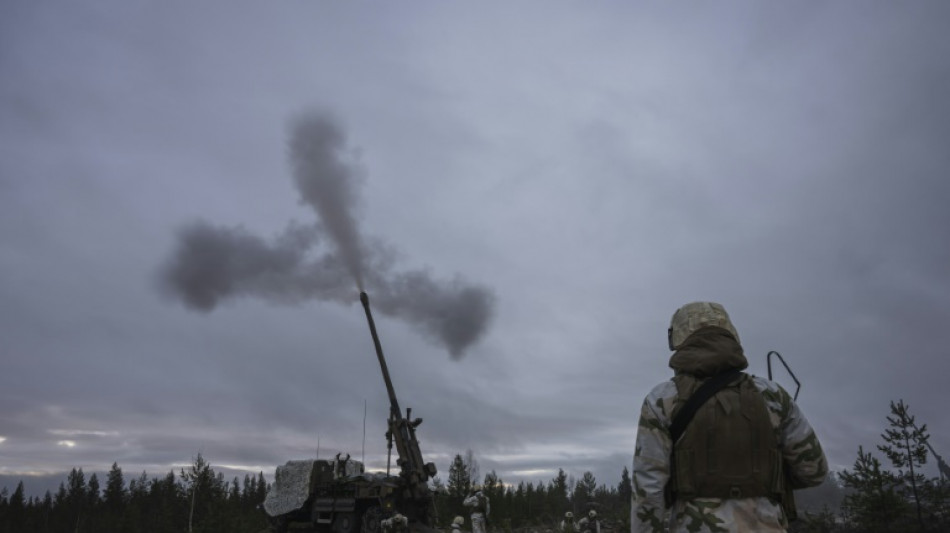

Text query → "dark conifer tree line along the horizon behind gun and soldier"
[0,400,950,533]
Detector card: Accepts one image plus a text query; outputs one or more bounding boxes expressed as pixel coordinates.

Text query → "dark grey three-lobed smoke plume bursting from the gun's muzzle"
[161,110,494,359]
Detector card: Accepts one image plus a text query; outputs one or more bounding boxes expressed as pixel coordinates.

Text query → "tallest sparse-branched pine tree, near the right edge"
[878,400,930,531]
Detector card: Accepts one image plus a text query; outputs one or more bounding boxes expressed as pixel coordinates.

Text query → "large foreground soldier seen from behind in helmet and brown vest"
[630,302,828,533]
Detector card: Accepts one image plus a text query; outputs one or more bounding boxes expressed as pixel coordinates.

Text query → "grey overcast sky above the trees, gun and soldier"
[0,0,950,496]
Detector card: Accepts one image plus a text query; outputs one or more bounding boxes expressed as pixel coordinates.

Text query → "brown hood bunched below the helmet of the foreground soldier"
[670,327,749,378]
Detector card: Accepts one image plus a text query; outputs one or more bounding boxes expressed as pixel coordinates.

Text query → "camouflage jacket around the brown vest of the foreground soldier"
[630,330,828,533]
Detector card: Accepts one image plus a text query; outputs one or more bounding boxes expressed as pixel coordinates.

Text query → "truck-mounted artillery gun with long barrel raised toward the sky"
[263,292,436,533]
